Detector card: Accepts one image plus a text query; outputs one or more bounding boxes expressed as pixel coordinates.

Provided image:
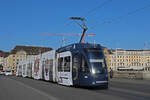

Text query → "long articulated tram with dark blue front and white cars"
[16,43,108,88]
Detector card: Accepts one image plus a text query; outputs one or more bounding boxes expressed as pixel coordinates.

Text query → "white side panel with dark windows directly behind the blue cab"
[57,51,73,86]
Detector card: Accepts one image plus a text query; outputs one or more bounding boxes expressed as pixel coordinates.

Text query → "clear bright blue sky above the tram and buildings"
[0,0,150,51]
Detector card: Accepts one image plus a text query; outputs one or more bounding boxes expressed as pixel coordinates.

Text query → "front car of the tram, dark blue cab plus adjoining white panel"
[56,43,108,88]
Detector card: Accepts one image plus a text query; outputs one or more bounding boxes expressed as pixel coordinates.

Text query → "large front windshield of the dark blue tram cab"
[85,48,106,74]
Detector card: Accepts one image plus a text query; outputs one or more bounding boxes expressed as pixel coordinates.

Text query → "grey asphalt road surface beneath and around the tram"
[0,76,150,100]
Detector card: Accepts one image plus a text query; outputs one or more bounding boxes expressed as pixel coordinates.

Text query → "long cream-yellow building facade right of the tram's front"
[108,49,150,70]
